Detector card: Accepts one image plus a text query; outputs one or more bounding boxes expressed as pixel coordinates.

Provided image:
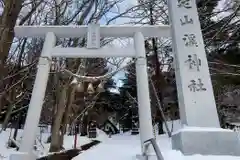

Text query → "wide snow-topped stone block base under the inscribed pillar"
[172,127,240,156]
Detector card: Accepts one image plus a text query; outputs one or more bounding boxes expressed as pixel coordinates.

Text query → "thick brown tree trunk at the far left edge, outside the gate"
[0,0,23,112]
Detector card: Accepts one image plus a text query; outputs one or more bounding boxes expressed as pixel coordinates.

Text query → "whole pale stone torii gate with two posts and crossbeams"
[12,25,170,160]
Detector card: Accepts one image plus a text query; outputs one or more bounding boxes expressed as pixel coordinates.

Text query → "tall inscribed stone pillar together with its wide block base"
[168,0,239,155]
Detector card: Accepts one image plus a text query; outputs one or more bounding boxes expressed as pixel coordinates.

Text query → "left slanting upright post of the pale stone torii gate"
[19,33,56,154]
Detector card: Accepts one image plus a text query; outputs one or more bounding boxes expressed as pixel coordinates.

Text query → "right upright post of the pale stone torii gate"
[134,32,154,155]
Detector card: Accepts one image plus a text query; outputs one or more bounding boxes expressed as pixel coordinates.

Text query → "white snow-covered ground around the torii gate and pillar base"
[0,121,240,160]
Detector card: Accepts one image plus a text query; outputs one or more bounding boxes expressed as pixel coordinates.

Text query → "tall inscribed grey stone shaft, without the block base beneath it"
[168,0,219,127]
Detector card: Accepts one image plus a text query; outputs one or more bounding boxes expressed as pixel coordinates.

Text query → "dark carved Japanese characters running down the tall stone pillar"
[177,0,207,92]
